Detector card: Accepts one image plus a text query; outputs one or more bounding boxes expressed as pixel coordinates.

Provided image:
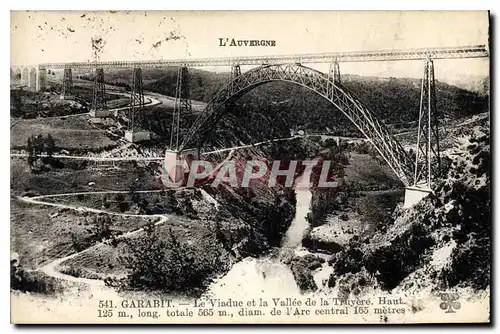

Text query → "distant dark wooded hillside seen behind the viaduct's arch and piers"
[74,67,489,147]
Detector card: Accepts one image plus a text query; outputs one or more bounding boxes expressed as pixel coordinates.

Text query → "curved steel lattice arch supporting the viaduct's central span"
[179,64,414,186]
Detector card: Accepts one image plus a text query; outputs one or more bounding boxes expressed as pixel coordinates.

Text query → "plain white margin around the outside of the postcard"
[0,0,500,334]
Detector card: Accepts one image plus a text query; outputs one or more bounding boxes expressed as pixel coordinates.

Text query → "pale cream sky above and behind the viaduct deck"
[11,11,489,81]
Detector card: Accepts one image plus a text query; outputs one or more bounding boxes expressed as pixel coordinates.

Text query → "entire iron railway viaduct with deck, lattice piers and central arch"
[11,45,489,206]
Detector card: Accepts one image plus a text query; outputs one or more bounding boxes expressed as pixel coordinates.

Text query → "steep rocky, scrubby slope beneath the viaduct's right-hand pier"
[332,117,491,291]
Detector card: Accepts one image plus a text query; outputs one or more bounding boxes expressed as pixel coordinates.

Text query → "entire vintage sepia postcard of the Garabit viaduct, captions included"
[10,11,492,324]
